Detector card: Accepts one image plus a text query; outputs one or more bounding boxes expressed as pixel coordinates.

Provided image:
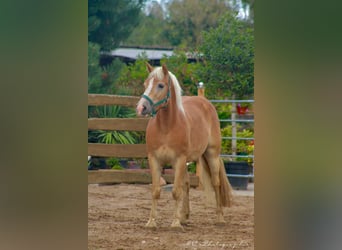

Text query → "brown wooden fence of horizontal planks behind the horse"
[88,94,199,186]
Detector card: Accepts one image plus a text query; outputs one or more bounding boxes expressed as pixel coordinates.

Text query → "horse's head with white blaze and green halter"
[136,63,171,115]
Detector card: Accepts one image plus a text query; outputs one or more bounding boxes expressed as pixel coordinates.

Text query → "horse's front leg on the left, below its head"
[146,155,161,229]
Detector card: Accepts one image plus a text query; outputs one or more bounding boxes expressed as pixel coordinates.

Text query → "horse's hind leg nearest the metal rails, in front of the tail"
[205,152,225,225]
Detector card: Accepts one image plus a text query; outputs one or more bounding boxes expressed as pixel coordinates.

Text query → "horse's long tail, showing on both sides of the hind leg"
[197,157,233,207]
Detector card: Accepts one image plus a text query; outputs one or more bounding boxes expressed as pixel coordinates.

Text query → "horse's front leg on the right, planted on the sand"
[171,156,187,231]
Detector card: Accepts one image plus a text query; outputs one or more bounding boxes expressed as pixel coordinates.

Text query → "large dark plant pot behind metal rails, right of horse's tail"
[224,161,251,190]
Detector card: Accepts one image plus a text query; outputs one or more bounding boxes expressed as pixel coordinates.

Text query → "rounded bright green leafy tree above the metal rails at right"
[197,13,254,99]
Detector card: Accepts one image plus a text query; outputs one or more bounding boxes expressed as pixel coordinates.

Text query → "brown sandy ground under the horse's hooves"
[88,184,254,250]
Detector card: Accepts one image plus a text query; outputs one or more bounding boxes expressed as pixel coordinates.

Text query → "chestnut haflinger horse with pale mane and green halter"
[136,63,232,231]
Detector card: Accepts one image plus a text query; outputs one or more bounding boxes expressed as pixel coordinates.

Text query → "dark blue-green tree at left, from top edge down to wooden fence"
[88,0,146,94]
